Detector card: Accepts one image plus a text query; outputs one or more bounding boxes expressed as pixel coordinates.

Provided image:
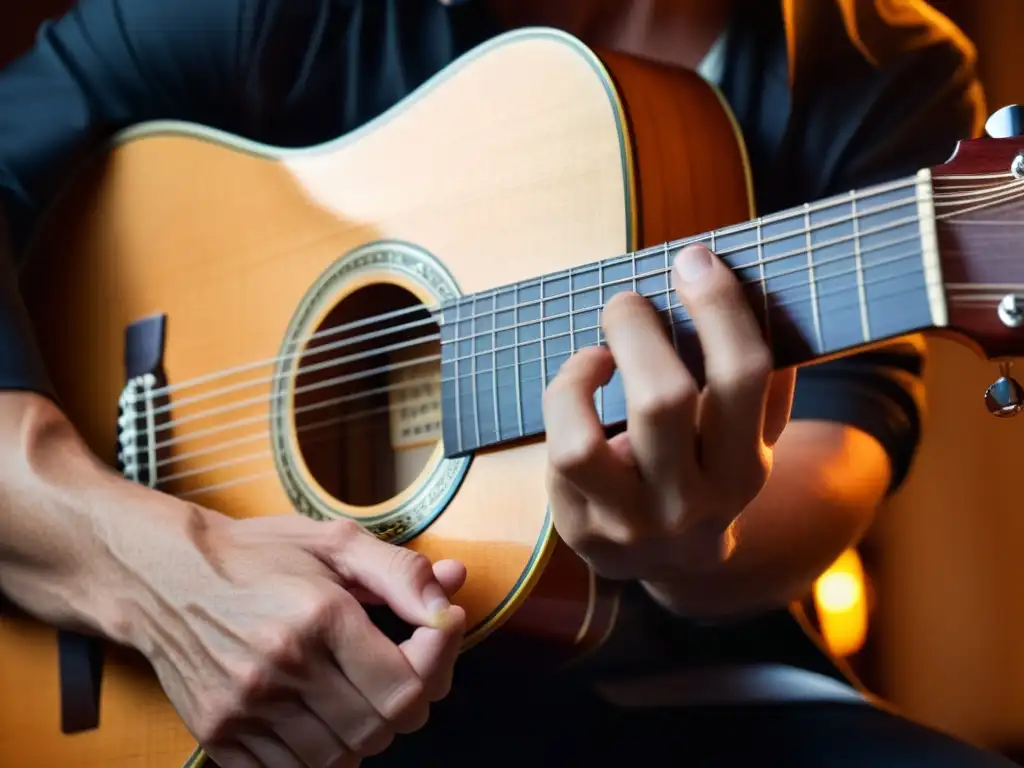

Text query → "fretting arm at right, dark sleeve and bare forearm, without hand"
[648,4,984,618]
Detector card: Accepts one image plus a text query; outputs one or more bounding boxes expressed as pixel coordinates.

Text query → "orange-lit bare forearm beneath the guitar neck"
[645,421,889,620]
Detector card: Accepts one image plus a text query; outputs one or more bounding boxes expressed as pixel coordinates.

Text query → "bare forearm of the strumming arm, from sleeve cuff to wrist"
[0,393,190,643]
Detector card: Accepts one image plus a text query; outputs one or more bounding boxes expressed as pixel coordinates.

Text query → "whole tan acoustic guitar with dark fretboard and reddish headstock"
[0,30,1024,768]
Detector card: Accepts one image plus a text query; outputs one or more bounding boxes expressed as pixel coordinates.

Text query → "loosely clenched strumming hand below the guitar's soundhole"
[110,508,466,768]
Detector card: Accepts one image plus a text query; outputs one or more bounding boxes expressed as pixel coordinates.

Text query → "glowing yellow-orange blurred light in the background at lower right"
[814,549,867,656]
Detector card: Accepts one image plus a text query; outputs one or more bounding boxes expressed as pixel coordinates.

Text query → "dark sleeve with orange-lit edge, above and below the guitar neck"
[778,2,984,490]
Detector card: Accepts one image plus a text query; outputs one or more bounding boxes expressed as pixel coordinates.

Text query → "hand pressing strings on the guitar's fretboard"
[544,246,794,583]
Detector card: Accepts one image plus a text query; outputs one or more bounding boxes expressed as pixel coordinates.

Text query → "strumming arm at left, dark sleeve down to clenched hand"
[0,0,465,766]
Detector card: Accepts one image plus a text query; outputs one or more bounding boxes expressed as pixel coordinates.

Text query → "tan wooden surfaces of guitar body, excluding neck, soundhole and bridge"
[0,30,750,768]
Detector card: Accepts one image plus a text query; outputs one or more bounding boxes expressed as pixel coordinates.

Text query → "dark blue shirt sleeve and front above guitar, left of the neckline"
[0,0,488,403]
